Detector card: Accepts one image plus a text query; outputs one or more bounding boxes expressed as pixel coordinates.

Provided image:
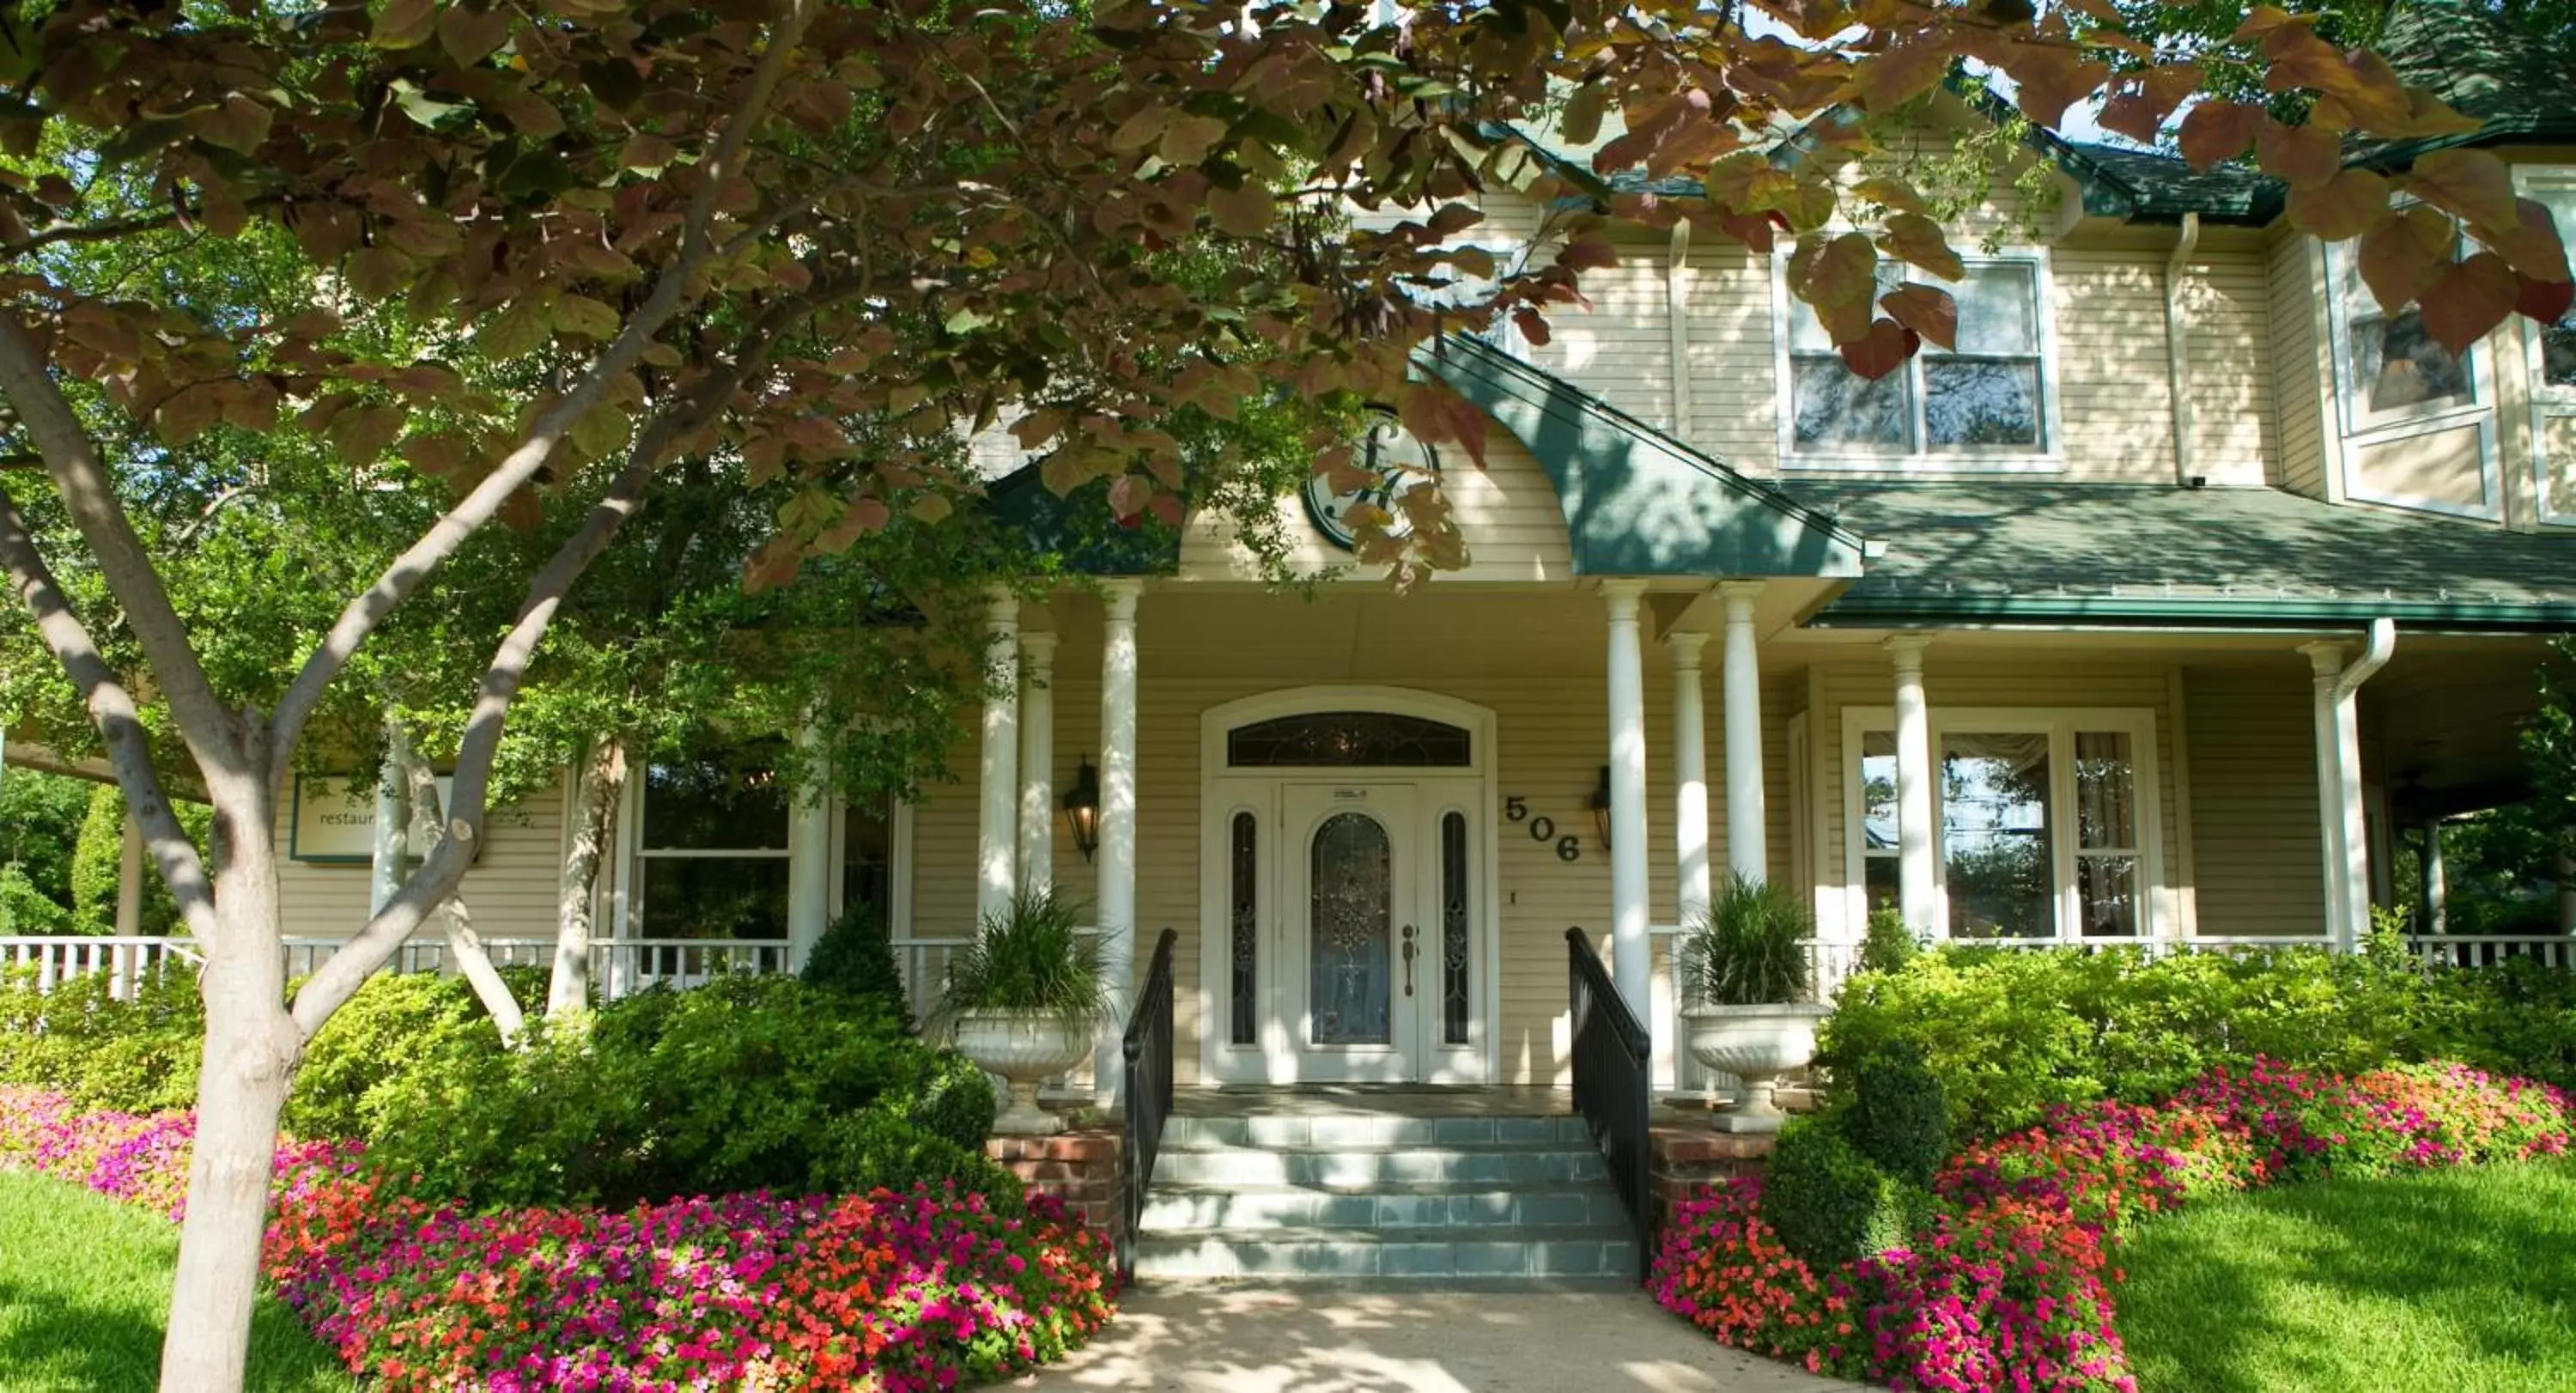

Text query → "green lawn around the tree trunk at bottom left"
[0,1171,355,1393]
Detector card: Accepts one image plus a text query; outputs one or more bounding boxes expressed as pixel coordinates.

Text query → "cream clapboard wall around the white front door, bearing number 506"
[912,636,1795,1084]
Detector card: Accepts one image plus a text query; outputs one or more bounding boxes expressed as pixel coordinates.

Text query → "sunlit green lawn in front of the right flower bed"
[2115,1161,2576,1393]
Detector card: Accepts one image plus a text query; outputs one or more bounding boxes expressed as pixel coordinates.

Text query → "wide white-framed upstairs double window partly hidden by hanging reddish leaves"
[1772,252,2058,469]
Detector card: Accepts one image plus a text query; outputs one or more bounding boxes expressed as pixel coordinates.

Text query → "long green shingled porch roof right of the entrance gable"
[1785,482,2576,631]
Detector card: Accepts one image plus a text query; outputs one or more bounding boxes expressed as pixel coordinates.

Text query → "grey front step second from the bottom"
[1144,1182,1628,1233]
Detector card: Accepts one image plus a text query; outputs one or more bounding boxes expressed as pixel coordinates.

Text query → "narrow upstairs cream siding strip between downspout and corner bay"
[2182,245,2280,487]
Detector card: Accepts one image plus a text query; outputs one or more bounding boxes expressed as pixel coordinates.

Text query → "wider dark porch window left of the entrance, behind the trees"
[629,746,788,940]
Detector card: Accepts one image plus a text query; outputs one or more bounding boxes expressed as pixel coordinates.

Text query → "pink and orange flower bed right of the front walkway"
[1649,1061,2576,1393]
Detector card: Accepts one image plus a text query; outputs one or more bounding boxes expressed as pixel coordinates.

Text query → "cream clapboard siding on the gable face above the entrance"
[1180,428,1574,585]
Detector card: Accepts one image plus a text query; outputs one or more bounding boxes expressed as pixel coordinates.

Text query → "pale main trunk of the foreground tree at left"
[160,798,304,1393]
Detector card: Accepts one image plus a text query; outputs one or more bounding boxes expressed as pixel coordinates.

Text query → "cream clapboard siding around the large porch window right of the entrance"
[1808,656,2210,934]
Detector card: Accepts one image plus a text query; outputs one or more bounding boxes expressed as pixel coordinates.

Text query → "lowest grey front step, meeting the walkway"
[1136,1226,1636,1285]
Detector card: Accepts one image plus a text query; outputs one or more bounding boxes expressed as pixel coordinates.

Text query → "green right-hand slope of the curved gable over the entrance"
[1414,335,1865,580]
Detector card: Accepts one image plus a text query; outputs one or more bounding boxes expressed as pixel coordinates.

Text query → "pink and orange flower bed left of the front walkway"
[0,1089,1113,1393]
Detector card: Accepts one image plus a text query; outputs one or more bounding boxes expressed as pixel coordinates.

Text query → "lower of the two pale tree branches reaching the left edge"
[0,490,214,942]
